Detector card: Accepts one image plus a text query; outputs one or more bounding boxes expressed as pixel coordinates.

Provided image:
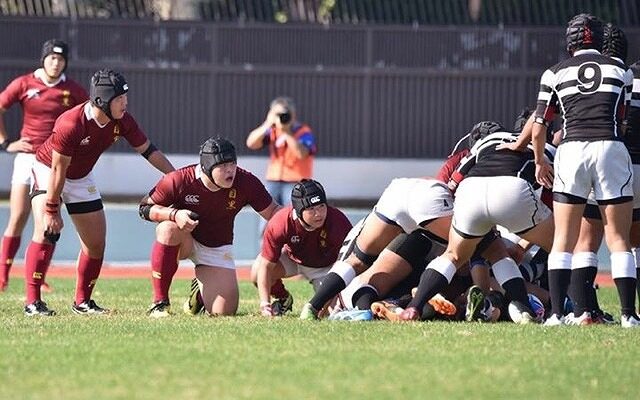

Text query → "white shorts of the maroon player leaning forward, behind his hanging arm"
[31,161,101,204]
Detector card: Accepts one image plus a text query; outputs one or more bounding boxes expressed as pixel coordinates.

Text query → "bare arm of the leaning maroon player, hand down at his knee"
[44,150,71,235]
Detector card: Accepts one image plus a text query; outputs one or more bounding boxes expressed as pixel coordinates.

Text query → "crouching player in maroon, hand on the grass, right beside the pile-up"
[251,179,351,317]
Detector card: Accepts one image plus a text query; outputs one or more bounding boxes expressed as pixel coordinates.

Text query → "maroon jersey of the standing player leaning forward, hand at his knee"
[36,103,147,179]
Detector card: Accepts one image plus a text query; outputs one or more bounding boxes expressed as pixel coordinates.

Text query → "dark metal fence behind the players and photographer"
[0,18,640,158]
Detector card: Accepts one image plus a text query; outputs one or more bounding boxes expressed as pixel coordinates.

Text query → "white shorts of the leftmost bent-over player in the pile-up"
[374,178,453,233]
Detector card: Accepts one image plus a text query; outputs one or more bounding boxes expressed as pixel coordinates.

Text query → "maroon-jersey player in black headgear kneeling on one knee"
[140,137,279,317]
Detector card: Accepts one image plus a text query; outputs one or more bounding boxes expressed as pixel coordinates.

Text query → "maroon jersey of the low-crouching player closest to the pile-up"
[260,206,351,268]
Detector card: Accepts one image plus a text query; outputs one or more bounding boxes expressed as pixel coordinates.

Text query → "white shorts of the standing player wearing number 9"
[553,140,633,201]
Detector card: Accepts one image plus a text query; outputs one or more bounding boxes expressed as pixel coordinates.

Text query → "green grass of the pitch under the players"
[0,279,640,400]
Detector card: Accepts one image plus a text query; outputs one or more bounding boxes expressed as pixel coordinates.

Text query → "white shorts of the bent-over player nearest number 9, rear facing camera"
[452,176,551,237]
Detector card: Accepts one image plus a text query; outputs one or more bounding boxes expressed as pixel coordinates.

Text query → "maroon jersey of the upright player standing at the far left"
[0,72,89,149]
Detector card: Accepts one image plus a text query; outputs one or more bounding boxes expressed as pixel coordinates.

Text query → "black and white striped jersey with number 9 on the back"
[535,49,633,143]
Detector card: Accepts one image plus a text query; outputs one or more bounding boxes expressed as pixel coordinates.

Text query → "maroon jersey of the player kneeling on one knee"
[149,164,272,247]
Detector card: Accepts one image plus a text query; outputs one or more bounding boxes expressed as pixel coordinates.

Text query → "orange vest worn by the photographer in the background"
[267,124,314,182]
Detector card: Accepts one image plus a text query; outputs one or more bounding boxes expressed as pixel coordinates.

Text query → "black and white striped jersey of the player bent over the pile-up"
[457,132,556,188]
